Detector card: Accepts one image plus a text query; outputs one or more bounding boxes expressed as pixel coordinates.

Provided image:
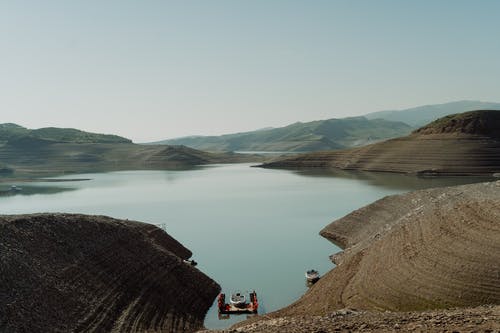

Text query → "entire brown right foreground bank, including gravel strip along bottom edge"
[204,181,500,332]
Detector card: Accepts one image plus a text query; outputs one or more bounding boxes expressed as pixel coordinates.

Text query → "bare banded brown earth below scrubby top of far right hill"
[262,134,500,175]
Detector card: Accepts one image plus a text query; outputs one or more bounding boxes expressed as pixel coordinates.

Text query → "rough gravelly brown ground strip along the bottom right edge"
[203,306,500,333]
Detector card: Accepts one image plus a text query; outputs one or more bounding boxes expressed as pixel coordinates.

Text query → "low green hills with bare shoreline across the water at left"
[0,124,259,177]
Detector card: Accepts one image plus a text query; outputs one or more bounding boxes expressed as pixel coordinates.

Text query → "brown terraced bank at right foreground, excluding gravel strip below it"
[278,181,500,316]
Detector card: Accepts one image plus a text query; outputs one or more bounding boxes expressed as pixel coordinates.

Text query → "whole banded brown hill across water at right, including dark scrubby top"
[263,110,500,175]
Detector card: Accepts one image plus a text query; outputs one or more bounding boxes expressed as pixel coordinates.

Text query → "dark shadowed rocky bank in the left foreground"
[0,214,220,332]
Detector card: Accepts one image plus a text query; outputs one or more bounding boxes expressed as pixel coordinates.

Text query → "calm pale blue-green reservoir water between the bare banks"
[0,164,488,328]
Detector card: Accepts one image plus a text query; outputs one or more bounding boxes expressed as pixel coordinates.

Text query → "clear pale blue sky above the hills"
[0,0,500,142]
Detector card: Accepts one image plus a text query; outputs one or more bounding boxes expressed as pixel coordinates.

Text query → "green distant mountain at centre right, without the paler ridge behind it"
[155,117,412,152]
